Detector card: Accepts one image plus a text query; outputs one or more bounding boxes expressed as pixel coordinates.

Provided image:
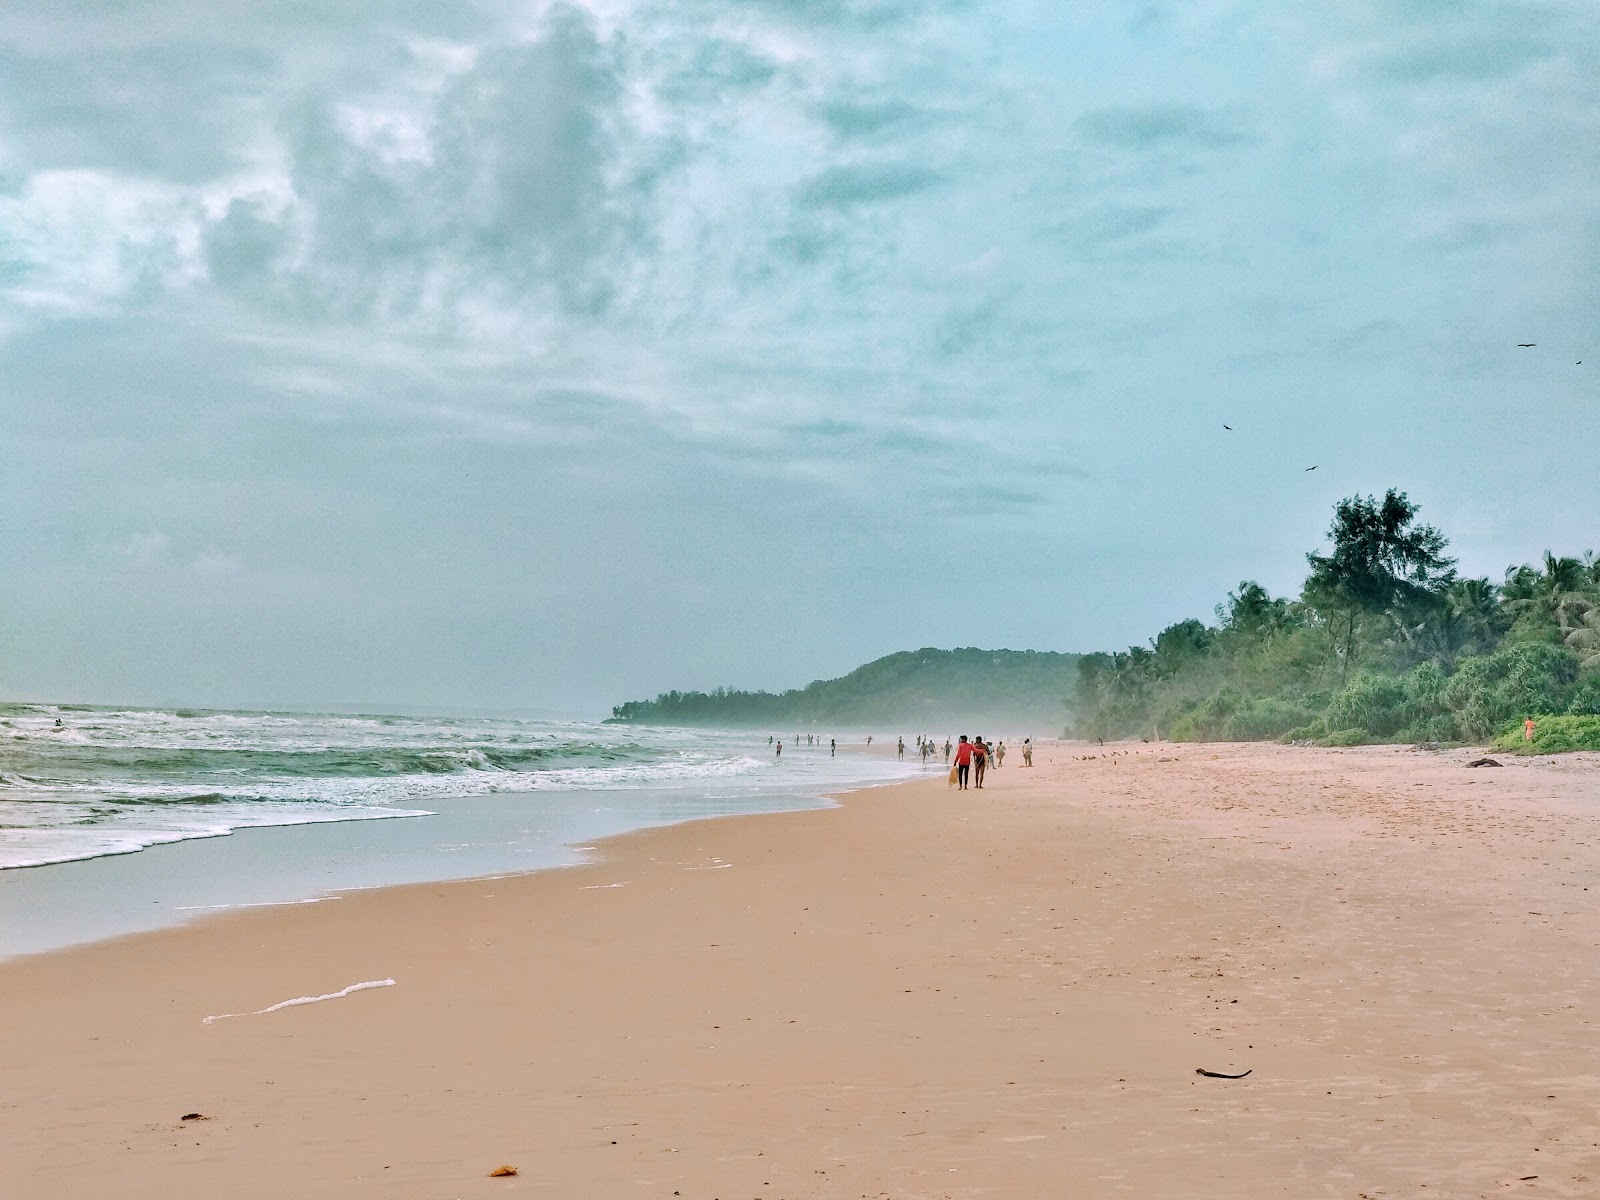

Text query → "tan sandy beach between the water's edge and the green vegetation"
[0,746,1600,1200]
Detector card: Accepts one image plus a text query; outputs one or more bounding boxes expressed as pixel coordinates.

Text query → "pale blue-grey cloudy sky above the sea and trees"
[0,0,1600,715]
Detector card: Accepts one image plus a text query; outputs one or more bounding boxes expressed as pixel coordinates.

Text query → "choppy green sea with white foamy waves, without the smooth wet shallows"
[0,704,910,870]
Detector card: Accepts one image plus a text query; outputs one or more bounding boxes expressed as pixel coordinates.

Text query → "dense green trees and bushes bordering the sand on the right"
[1075,490,1600,752]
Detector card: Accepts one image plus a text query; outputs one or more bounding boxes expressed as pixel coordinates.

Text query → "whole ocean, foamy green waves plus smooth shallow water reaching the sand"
[0,704,923,955]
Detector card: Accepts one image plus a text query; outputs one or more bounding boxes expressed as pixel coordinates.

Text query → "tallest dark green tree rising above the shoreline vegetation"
[1306,488,1456,677]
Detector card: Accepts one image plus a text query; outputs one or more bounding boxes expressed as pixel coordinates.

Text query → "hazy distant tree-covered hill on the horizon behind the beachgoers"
[611,648,1080,738]
